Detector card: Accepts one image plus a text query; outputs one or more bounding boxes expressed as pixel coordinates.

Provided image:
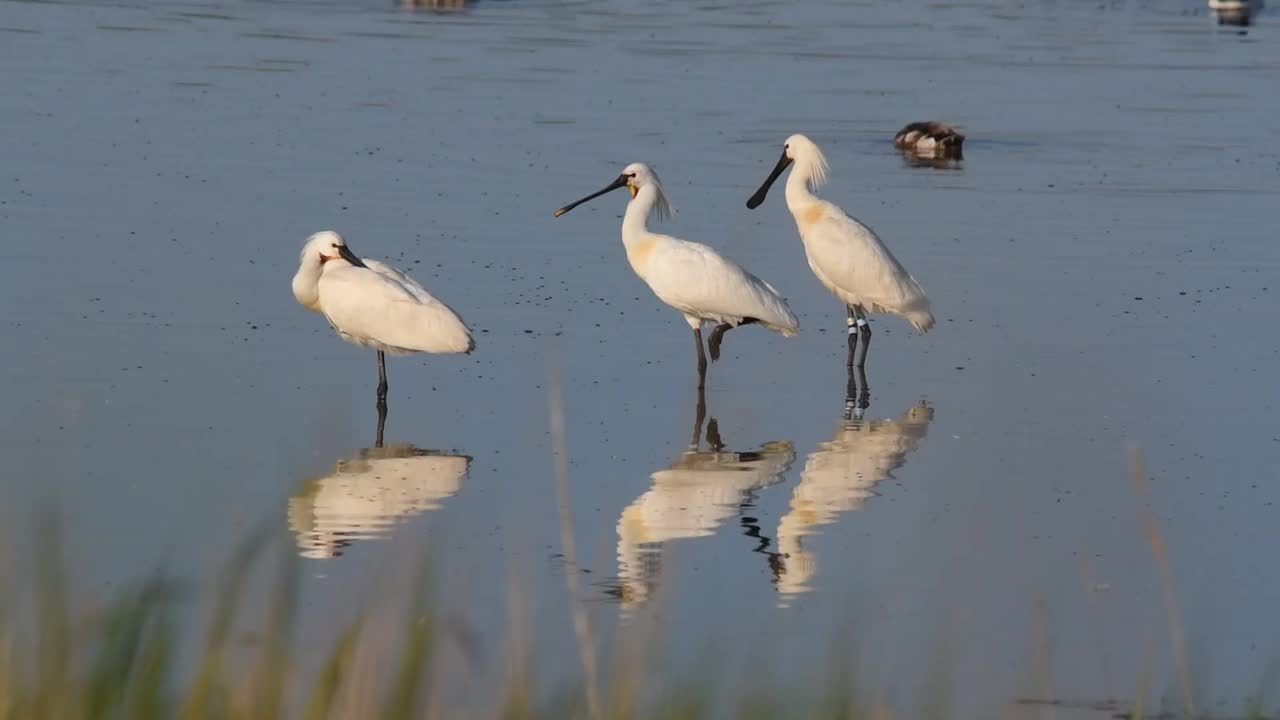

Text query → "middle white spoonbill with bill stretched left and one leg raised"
[556,163,800,387]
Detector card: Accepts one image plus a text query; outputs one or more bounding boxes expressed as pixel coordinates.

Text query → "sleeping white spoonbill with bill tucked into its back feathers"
[293,231,475,409]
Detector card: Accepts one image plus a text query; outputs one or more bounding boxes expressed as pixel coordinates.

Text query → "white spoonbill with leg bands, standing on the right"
[746,135,933,368]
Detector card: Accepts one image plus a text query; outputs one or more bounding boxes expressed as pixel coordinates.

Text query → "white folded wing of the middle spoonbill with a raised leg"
[645,236,800,336]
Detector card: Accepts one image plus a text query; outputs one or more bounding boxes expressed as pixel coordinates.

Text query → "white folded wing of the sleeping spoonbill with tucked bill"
[320,260,475,352]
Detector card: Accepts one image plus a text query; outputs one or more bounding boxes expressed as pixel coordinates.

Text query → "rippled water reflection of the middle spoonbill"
[609,389,795,610]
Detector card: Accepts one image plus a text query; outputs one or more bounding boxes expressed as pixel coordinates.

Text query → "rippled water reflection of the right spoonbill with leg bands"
[771,369,933,605]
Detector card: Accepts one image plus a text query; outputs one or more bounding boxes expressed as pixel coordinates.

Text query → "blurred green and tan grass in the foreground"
[0,447,1275,720]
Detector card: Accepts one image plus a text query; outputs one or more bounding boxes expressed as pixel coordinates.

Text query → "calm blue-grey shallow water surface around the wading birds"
[0,0,1280,707]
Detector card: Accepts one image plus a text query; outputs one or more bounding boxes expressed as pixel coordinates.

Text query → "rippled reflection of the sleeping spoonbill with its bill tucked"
[288,407,471,559]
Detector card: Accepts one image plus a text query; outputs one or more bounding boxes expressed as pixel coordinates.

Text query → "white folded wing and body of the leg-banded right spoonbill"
[801,204,933,332]
